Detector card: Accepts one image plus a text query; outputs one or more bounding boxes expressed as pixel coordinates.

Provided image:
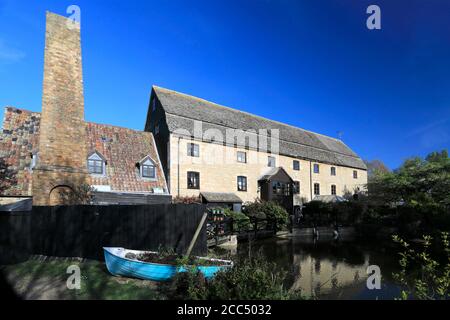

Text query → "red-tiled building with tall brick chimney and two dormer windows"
[0,12,170,205]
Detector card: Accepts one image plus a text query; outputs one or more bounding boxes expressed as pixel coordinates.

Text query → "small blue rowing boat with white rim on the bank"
[103,247,233,281]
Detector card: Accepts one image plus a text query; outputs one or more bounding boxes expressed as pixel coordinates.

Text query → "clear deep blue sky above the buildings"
[0,0,450,168]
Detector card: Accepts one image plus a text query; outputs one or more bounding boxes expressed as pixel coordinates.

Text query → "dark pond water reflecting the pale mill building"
[215,237,400,300]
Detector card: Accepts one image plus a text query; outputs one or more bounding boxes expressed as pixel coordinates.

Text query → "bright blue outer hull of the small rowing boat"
[103,248,231,281]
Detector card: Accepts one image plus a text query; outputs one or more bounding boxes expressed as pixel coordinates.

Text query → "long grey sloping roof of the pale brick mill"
[153,86,367,170]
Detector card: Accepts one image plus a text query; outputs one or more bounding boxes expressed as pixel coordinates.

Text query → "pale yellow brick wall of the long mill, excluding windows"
[170,135,367,201]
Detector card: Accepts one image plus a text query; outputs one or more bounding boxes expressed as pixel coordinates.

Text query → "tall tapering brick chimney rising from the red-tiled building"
[33,12,88,205]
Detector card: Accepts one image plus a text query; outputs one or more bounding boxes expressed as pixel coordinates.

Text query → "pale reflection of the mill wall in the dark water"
[292,254,369,295]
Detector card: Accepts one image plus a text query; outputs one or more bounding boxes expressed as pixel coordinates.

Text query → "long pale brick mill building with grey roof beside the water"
[145,86,367,209]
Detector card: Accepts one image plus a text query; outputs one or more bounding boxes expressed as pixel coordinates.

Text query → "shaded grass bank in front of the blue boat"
[1,259,165,300]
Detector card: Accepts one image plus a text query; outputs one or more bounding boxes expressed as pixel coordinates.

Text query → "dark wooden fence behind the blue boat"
[0,204,207,264]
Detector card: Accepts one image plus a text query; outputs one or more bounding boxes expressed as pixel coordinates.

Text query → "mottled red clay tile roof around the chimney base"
[0,107,167,196]
